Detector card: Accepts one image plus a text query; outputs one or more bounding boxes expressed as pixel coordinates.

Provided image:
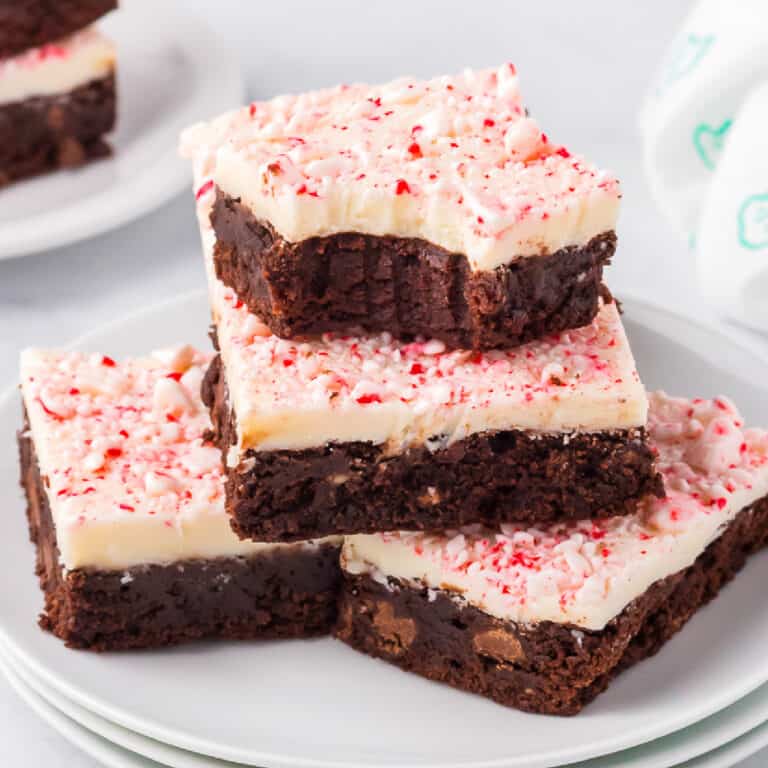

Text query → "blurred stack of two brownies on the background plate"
[0,0,117,186]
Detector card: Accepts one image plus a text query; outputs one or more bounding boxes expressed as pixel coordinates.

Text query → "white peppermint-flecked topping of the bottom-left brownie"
[21,347,338,570]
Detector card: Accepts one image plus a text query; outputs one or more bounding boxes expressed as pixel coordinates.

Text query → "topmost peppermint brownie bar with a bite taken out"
[182,65,620,349]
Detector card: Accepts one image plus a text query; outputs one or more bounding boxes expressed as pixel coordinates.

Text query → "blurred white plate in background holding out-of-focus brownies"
[0,0,244,259]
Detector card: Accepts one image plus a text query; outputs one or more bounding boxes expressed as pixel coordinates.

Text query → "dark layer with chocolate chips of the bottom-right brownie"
[336,499,768,715]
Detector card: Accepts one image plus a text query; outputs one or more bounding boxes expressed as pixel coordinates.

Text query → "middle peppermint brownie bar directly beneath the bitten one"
[201,201,662,541]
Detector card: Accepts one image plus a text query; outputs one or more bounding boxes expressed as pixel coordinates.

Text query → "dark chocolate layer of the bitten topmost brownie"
[211,190,616,349]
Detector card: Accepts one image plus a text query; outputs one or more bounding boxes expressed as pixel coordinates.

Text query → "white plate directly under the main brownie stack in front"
[0,293,768,768]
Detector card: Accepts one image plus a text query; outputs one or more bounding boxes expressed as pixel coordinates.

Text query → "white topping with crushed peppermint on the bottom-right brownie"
[342,393,768,630]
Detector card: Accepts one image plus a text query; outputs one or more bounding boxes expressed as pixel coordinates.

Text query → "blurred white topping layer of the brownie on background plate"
[0,27,115,104]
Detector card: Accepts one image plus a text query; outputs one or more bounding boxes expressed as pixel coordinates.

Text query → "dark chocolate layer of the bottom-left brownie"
[19,424,341,651]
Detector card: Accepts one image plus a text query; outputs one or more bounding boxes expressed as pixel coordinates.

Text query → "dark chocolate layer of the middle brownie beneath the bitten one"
[202,357,664,541]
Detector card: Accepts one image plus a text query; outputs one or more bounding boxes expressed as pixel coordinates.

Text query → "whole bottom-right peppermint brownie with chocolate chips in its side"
[337,394,768,715]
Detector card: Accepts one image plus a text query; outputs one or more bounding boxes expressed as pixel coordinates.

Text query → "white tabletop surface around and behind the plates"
[0,0,768,768]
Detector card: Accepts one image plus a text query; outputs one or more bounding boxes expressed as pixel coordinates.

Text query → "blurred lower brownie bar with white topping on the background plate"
[0,27,116,186]
